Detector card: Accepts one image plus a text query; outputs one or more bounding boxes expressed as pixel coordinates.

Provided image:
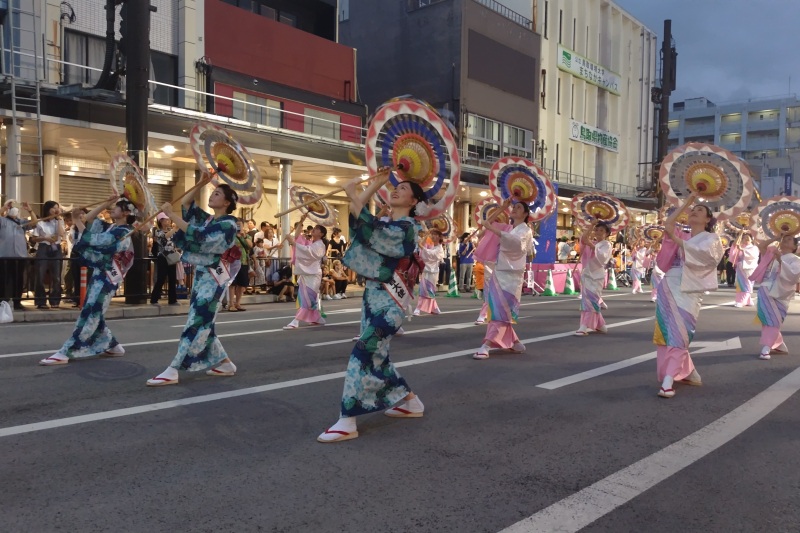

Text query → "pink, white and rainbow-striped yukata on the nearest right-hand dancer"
[653,231,723,381]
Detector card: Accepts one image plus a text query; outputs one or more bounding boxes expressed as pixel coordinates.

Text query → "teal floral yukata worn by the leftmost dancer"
[56,219,133,359]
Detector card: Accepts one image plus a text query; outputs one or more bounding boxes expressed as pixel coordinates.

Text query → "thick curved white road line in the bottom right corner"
[501,369,800,533]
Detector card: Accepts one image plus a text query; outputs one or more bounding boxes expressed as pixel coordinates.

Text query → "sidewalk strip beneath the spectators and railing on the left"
[7,285,364,322]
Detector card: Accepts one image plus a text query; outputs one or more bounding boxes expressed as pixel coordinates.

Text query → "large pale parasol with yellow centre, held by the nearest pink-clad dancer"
[659,143,753,220]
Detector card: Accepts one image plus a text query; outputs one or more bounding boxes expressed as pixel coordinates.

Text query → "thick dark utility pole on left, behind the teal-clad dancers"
[118,0,155,304]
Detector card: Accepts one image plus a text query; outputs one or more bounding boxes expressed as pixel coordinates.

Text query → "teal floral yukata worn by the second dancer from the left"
[170,202,237,372]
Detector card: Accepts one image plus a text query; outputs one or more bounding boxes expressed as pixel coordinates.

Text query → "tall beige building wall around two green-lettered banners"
[523,0,658,196]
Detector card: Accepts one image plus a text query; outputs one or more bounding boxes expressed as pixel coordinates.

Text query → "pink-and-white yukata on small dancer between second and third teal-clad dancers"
[293,235,325,324]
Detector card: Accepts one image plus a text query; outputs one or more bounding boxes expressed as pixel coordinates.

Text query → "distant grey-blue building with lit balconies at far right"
[669,95,800,198]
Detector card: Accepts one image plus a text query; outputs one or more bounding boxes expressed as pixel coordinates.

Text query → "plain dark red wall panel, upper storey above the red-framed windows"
[204,0,356,101]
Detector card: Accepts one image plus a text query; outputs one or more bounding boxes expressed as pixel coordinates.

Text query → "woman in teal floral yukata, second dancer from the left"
[147,181,239,387]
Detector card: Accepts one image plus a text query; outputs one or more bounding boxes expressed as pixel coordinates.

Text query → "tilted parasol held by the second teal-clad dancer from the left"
[189,122,264,205]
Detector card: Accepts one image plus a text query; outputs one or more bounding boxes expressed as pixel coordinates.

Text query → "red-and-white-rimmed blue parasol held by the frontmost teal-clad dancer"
[366,98,461,220]
